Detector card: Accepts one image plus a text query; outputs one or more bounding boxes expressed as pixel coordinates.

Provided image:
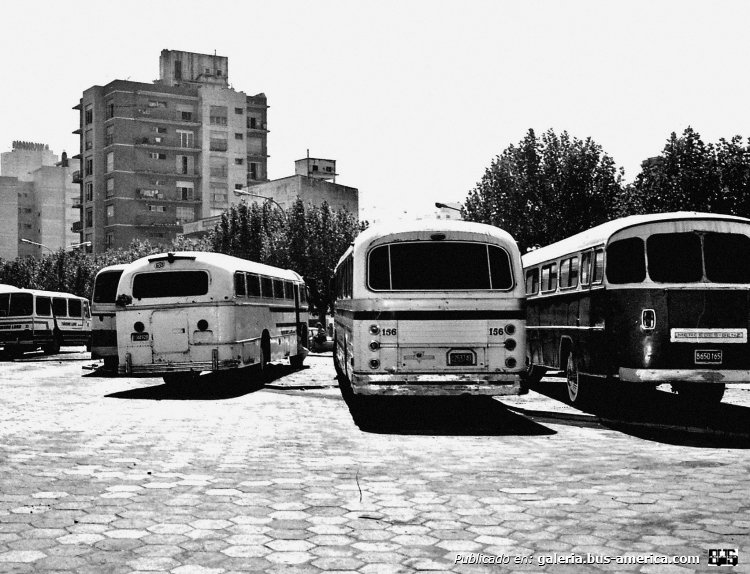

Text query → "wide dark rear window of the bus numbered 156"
[368,242,513,291]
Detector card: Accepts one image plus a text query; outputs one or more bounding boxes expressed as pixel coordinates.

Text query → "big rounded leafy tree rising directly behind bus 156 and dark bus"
[464,130,622,252]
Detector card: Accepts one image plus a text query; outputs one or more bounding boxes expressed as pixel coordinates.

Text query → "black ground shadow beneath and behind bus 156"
[346,397,555,436]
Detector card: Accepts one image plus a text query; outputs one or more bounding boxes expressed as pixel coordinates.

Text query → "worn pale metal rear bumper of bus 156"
[352,373,525,396]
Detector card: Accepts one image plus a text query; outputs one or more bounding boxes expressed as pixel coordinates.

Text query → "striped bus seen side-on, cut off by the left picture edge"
[0,285,91,356]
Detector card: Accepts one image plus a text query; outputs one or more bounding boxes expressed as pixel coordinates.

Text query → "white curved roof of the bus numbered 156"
[337,219,516,265]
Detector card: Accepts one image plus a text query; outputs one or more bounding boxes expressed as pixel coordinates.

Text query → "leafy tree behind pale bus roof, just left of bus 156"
[211,199,360,316]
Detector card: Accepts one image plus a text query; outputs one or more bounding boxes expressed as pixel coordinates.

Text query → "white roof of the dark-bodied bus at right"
[522,211,750,267]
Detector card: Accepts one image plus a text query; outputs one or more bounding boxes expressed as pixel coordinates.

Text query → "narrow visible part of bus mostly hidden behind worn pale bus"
[91,263,127,370]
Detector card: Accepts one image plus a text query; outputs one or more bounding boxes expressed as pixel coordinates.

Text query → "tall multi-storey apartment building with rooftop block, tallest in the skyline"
[74,50,268,252]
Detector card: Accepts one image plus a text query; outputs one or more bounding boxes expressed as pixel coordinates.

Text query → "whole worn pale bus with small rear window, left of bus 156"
[116,252,308,383]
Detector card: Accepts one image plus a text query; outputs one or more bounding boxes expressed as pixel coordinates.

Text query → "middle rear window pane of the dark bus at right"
[646,233,703,283]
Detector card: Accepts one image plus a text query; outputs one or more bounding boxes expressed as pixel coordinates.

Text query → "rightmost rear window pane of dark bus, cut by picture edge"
[703,233,750,283]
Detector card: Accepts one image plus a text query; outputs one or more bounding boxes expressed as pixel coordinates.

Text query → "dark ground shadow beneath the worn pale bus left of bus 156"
[105,365,295,401]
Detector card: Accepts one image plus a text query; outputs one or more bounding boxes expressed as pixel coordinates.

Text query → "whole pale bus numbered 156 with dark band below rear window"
[333,220,526,409]
